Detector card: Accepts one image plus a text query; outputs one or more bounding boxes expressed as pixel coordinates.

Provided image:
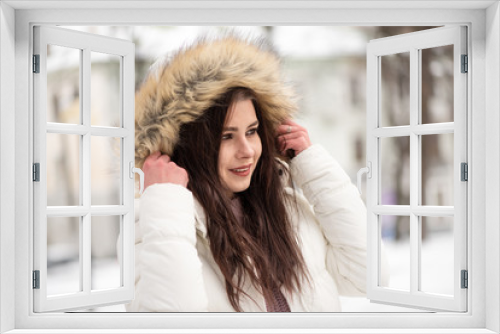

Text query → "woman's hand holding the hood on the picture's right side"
[277,119,311,156]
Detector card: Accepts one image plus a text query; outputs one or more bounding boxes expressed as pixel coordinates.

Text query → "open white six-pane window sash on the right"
[367,26,468,312]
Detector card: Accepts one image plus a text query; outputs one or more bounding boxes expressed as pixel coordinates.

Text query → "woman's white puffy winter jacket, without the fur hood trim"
[126,145,378,312]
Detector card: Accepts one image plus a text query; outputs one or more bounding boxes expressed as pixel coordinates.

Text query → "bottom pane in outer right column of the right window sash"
[420,217,454,295]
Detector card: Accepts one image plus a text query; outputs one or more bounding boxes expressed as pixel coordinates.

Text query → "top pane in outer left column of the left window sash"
[47,45,81,124]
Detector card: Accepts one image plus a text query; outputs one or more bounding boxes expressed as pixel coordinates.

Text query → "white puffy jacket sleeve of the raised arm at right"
[291,144,385,296]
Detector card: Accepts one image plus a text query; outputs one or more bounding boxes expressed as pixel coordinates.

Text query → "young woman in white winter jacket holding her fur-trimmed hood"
[127,36,386,312]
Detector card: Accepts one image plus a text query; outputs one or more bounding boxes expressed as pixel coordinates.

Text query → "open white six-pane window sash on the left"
[33,26,135,312]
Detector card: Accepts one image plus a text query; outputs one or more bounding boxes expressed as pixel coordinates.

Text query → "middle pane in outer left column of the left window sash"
[47,133,81,206]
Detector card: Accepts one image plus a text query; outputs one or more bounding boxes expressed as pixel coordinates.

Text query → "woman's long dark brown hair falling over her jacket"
[171,87,307,311]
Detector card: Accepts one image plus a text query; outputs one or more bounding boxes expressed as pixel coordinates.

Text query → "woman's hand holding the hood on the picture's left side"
[142,151,189,190]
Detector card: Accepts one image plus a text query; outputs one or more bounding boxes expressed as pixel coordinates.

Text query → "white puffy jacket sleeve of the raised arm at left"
[127,184,208,312]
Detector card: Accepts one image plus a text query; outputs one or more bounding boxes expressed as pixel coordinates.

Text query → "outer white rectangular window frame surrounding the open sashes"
[0,0,500,333]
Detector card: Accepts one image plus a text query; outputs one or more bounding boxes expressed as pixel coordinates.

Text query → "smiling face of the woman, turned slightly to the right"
[218,100,262,196]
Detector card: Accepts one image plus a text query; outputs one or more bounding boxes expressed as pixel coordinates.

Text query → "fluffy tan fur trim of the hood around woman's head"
[135,35,296,168]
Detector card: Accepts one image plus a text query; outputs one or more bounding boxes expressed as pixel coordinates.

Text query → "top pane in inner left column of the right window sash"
[380,52,410,126]
